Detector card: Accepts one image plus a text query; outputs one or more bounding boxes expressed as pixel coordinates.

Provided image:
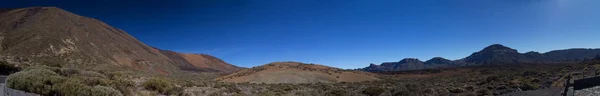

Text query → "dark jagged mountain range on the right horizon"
[359,44,600,72]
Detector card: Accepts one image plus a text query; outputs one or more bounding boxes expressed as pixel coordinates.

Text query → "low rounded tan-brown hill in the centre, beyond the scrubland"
[215,62,379,83]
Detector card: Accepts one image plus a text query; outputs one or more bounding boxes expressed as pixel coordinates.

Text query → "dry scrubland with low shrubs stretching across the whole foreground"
[2,61,600,96]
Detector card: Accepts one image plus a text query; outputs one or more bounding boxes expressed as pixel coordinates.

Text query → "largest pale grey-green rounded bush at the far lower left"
[7,68,66,95]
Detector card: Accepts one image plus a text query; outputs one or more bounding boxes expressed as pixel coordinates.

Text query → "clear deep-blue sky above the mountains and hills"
[0,0,600,68]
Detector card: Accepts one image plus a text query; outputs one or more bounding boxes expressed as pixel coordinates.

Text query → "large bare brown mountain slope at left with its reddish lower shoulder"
[0,7,238,74]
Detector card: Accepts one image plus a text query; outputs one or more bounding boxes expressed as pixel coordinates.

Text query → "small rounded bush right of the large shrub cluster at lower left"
[142,78,183,95]
